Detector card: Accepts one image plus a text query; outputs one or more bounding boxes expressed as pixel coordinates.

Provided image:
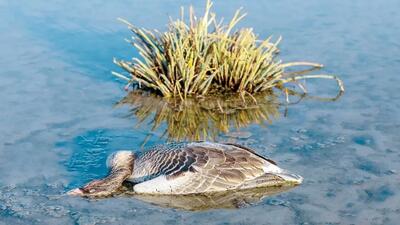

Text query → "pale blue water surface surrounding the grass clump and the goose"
[0,0,400,225]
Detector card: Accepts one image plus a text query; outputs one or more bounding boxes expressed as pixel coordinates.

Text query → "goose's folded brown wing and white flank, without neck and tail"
[135,142,274,194]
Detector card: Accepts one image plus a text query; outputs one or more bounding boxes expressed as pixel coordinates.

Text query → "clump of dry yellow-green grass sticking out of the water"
[113,0,344,98]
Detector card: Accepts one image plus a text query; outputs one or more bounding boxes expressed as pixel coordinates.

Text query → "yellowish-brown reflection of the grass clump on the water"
[117,90,279,140]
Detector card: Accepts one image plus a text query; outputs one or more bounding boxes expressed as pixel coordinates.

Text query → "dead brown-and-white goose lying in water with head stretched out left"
[68,142,303,197]
